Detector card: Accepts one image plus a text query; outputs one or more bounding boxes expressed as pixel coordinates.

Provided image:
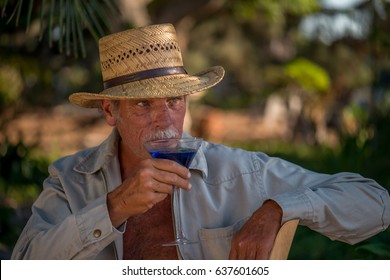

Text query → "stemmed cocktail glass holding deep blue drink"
[144,138,203,246]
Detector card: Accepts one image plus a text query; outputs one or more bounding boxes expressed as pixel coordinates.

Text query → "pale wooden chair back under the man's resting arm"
[269,219,299,260]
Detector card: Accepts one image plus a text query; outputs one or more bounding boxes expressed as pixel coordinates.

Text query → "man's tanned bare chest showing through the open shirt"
[123,196,178,260]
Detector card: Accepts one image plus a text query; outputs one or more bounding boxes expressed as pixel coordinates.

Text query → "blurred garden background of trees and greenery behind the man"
[0,0,390,259]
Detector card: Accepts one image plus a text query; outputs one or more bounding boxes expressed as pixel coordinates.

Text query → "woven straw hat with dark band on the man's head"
[69,24,225,108]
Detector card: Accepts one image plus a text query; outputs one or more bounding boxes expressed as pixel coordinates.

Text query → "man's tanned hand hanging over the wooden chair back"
[229,200,283,260]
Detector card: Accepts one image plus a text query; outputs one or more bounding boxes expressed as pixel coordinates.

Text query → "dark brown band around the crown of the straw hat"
[103,66,187,89]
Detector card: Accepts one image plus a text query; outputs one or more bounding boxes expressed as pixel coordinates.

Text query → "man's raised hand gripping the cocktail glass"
[107,159,191,227]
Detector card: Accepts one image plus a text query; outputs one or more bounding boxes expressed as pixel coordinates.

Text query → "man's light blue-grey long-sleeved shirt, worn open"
[12,130,390,259]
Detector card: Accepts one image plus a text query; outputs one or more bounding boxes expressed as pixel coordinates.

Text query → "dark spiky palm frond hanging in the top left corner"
[1,0,119,57]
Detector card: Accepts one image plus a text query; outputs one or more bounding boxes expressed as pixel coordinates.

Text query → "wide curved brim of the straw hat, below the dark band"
[69,66,225,108]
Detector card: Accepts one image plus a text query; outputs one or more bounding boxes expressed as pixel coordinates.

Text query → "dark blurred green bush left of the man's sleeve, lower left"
[0,140,49,259]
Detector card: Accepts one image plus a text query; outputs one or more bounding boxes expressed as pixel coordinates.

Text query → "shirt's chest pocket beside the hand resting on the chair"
[199,217,249,260]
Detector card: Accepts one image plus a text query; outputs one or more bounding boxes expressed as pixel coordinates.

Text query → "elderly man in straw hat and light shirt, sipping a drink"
[12,24,390,259]
